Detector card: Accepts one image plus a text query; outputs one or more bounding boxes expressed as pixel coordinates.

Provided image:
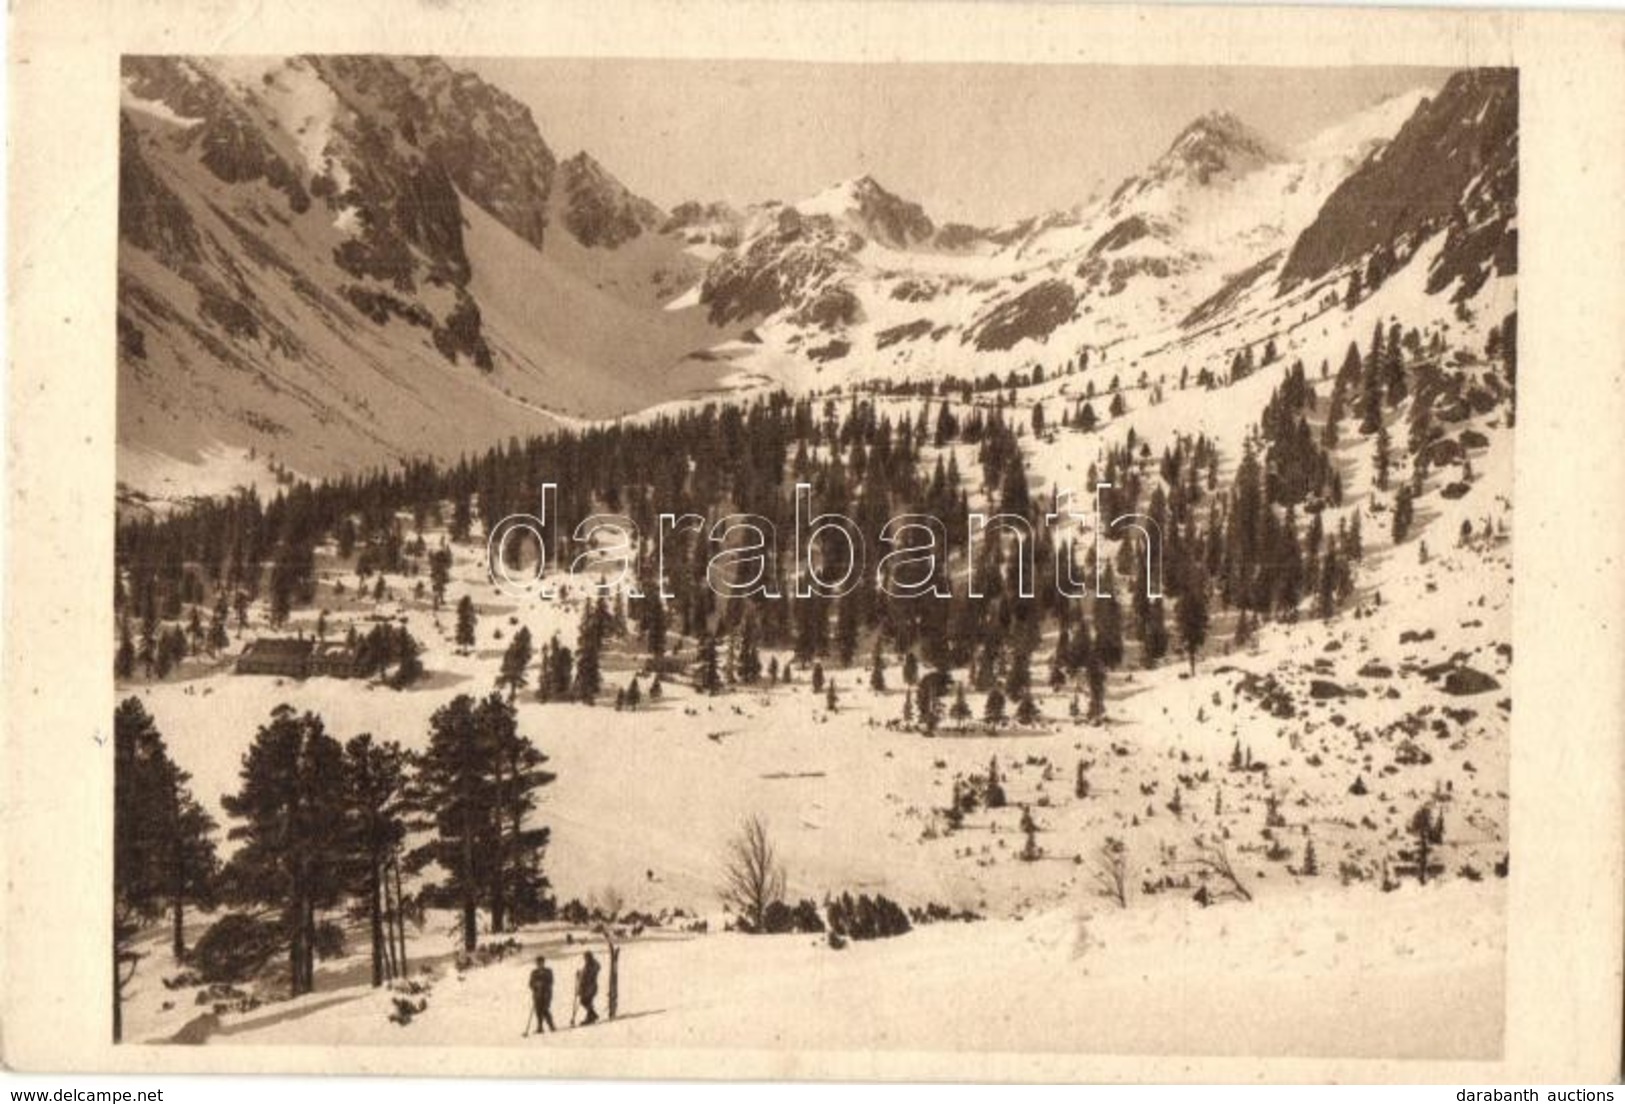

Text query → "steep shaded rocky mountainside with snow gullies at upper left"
[119,57,730,489]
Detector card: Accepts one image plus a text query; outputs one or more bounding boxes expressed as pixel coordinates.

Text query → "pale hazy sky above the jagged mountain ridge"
[468,59,1448,224]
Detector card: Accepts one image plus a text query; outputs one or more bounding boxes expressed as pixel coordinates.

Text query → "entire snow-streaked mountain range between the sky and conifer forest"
[119,57,1516,491]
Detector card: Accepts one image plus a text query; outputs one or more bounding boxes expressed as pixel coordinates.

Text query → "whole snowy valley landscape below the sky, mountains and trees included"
[112,59,1518,1058]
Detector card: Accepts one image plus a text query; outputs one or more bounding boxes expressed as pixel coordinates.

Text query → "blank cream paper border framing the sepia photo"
[0,0,1625,1083]
